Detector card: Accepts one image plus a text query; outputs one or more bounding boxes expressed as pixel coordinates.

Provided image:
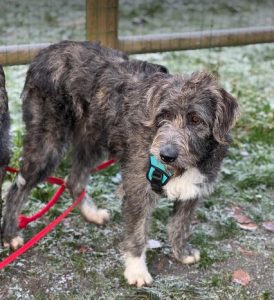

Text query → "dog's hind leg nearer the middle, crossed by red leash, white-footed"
[67,138,109,225]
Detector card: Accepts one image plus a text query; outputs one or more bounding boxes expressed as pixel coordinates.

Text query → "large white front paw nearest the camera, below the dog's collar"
[124,254,153,287]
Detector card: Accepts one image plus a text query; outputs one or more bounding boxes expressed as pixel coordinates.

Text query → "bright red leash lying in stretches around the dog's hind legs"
[0,160,115,270]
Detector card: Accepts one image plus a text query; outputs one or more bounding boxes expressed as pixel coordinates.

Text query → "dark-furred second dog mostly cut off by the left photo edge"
[0,65,10,238]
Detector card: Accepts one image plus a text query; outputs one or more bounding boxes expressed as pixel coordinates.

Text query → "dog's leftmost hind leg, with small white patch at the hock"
[2,128,65,249]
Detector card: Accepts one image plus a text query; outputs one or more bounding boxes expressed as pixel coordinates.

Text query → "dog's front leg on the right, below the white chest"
[168,199,200,264]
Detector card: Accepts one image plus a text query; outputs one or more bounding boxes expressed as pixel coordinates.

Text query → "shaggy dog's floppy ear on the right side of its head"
[213,89,240,144]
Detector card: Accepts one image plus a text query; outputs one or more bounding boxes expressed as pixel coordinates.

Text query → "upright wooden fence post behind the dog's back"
[86,0,119,48]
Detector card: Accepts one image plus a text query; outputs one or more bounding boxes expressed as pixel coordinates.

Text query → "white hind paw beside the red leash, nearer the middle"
[79,199,110,225]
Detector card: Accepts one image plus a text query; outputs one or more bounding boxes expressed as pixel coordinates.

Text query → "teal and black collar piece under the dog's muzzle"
[147,154,174,192]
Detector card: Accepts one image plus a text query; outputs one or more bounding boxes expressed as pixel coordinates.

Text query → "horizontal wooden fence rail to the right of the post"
[118,26,274,54]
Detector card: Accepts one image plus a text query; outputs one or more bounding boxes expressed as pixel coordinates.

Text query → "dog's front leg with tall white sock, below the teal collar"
[122,181,155,287]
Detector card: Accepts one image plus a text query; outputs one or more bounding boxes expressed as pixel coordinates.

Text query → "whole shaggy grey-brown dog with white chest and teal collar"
[3,41,238,287]
